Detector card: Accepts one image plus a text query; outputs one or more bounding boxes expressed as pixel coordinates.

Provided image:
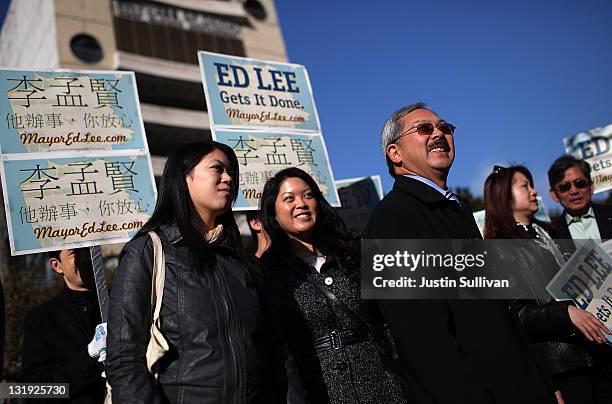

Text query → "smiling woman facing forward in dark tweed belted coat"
[261,168,406,404]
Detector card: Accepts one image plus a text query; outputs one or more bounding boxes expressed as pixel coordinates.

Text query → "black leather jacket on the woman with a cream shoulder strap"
[106,225,286,404]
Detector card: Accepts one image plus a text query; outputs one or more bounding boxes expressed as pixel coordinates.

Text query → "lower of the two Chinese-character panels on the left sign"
[3,155,155,254]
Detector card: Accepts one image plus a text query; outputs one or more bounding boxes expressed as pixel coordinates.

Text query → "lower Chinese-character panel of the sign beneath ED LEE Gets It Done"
[216,130,340,209]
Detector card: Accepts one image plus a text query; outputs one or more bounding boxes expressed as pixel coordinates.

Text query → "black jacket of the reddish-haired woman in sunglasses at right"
[496,238,593,374]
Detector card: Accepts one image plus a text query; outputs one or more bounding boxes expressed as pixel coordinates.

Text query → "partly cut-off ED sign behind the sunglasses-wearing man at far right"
[563,124,612,193]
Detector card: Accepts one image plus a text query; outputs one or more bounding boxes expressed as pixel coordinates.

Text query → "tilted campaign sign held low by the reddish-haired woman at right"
[546,240,612,344]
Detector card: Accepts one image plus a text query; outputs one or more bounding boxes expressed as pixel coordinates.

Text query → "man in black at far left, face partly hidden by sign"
[23,248,105,404]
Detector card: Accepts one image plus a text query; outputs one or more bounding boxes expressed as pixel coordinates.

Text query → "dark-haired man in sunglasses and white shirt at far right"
[548,155,612,240]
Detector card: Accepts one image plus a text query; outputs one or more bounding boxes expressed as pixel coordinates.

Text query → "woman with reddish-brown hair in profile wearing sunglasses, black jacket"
[484,166,609,404]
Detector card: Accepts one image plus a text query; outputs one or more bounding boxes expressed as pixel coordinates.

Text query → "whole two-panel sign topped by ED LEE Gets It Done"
[198,52,340,211]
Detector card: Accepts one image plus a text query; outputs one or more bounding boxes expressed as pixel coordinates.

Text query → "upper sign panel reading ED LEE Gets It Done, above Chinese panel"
[198,52,320,132]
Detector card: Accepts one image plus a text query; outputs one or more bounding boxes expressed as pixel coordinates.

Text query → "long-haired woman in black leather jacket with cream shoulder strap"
[106,141,286,404]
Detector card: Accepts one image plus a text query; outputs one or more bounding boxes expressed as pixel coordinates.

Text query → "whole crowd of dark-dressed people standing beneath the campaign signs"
[19,103,612,404]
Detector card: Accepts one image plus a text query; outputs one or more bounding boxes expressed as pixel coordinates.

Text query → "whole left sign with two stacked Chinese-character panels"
[0,70,156,255]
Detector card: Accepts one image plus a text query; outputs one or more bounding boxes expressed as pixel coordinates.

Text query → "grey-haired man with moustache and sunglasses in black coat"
[366,103,555,404]
